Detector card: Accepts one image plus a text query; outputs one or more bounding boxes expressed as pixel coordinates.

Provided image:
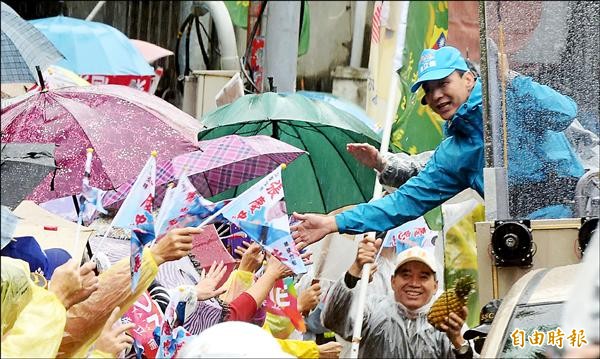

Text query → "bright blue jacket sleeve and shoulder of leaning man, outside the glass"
[335,80,484,234]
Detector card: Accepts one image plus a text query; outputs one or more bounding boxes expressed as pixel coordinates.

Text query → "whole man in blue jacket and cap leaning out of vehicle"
[292,46,583,248]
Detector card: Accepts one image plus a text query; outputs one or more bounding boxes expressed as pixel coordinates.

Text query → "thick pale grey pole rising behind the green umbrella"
[265,1,300,92]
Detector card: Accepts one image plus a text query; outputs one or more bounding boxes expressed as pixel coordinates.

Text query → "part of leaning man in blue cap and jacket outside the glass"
[291,46,484,248]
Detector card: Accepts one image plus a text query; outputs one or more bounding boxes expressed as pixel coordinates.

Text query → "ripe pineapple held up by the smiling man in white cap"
[427,275,473,328]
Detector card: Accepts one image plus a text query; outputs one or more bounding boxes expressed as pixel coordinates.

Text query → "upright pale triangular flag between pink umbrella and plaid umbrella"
[111,152,156,235]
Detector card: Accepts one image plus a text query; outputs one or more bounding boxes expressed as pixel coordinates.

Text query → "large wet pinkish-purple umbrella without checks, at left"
[1,85,201,203]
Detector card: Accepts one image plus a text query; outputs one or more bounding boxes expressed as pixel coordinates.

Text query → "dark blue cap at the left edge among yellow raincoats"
[2,236,71,280]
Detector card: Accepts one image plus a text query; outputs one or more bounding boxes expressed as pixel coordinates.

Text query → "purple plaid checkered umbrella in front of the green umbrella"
[102,135,306,207]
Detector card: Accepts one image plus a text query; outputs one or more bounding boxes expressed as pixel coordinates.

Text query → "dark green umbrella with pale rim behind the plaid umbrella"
[198,92,381,213]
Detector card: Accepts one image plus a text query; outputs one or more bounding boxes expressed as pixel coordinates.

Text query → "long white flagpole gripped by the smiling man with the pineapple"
[350,1,409,359]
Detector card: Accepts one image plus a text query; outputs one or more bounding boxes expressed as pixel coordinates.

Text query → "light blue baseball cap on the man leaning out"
[410,46,469,92]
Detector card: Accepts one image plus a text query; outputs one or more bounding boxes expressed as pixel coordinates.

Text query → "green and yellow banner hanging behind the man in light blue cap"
[390,1,448,154]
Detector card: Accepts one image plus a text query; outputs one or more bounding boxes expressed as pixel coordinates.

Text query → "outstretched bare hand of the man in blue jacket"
[290,212,338,250]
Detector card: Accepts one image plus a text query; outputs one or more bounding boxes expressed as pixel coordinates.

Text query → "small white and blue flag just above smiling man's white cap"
[383,217,436,253]
